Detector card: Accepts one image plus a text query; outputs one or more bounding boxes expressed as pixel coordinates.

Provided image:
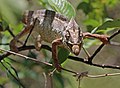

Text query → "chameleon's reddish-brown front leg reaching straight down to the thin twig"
[52,38,62,71]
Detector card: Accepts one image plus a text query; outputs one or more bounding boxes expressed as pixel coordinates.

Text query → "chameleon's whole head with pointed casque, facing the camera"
[63,18,83,55]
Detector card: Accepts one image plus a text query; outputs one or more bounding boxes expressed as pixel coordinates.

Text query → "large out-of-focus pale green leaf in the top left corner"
[0,0,27,24]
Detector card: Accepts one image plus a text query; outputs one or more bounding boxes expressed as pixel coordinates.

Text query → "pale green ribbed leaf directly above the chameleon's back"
[48,0,76,18]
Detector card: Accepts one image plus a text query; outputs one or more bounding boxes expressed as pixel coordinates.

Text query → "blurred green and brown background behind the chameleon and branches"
[0,0,120,88]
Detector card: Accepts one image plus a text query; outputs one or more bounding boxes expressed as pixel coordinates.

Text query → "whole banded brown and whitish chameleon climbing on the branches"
[10,10,109,71]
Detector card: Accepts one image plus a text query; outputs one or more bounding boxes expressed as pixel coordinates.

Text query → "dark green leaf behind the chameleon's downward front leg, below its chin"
[58,48,70,63]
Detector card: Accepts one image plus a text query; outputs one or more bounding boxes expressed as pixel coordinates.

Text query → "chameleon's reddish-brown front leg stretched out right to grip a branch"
[83,32,109,44]
